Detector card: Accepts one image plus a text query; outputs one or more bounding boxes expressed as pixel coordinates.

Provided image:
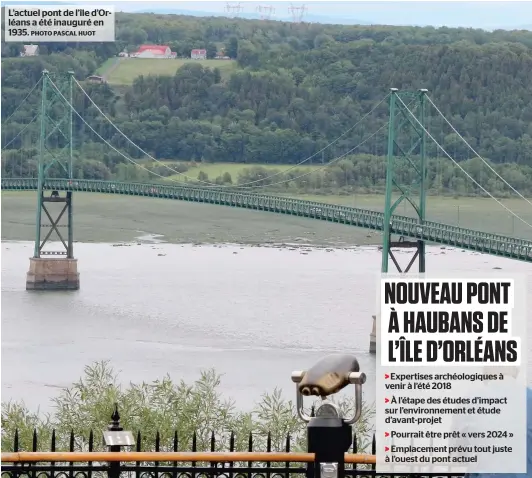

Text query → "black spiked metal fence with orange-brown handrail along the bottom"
[1,413,459,478]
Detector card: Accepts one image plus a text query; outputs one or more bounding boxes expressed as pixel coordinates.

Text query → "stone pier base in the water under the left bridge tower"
[26,257,79,290]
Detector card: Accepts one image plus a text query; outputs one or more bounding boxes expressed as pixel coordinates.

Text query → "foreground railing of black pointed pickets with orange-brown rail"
[2,432,376,478]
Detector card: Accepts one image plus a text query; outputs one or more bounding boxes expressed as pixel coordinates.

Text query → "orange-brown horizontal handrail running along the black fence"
[2,451,377,465]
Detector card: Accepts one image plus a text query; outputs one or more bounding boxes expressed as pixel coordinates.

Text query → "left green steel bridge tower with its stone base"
[26,70,79,290]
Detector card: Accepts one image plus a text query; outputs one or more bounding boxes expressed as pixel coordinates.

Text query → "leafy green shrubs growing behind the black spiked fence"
[2,362,374,451]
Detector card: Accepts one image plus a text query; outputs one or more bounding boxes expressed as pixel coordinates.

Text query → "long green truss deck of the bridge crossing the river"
[2,178,532,262]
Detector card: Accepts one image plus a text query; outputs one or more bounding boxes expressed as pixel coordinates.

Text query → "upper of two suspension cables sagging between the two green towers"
[74,78,389,189]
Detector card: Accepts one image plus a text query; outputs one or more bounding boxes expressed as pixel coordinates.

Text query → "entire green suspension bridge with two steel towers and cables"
[1,71,532,300]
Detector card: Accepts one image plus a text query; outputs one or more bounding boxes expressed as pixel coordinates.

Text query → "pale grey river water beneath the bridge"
[1,242,532,411]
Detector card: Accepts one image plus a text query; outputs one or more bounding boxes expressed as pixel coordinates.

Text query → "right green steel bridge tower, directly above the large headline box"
[370,88,427,353]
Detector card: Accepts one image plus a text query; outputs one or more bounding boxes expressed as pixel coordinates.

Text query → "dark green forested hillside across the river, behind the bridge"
[2,14,532,196]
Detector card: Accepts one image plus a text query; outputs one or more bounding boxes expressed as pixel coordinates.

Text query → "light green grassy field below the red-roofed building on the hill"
[96,58,236,85]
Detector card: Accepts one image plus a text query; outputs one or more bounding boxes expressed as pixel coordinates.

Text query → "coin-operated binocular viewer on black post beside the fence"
[292,355,366,478]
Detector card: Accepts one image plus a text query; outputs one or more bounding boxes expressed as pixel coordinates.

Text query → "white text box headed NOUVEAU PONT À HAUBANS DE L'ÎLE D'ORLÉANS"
[376,274,528,474]
